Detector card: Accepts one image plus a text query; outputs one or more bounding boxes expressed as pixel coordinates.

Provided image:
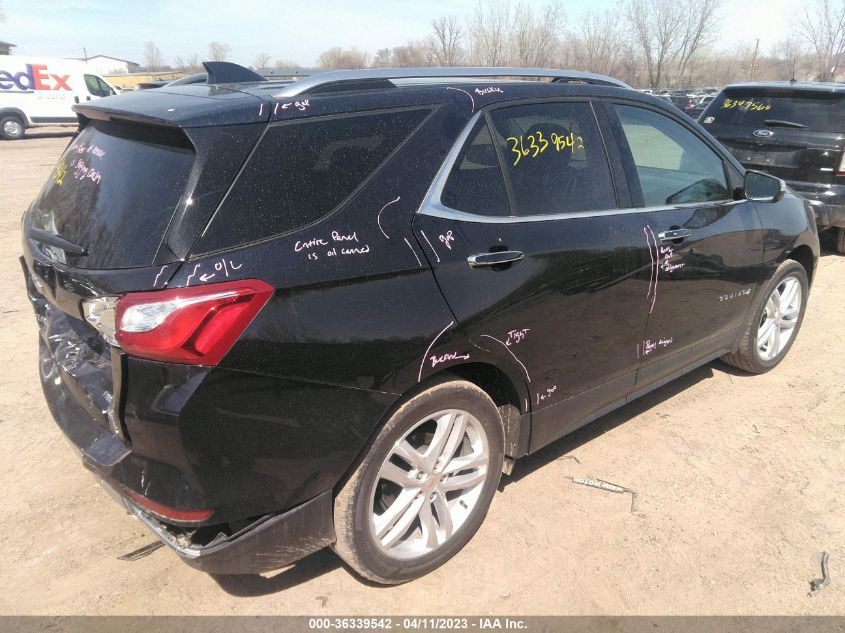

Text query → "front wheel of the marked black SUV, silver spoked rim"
[722,259,809,374]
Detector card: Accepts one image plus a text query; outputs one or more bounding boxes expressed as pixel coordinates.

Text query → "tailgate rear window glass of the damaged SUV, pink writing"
[31,121,194,269]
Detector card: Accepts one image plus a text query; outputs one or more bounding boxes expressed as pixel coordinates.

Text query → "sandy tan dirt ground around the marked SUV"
[0,129,845,615]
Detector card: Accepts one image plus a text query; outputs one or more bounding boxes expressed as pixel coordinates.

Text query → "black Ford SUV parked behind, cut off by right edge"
[698,81,845,253]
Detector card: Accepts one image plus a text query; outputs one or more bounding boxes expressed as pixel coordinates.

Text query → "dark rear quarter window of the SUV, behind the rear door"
[195,108,431,253]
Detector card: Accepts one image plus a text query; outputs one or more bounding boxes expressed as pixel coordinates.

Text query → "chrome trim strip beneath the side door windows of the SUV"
[417,110,745,224]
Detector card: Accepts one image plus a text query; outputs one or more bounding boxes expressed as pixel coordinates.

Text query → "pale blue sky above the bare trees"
[0,0,799,66]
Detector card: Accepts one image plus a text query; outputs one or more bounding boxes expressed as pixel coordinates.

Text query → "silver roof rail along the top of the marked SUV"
[273,66,631,98]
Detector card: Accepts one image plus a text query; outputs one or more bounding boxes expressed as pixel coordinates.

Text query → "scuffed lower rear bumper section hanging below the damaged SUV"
[99,479,335,574]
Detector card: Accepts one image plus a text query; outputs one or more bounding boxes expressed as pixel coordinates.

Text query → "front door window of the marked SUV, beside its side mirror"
[615,105,730,207]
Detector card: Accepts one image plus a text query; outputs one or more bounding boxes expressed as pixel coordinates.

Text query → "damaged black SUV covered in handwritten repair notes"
[21,64,818,583]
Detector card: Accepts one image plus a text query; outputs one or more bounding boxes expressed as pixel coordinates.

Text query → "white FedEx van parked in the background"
[0,55,117,139]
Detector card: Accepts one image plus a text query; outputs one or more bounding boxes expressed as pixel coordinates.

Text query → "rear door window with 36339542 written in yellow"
[490,102,617,216]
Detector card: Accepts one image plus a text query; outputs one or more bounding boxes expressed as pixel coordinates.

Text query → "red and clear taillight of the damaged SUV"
[83,279,273,365]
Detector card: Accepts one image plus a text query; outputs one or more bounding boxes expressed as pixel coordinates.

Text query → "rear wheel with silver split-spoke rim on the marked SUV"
[334,380,504,585]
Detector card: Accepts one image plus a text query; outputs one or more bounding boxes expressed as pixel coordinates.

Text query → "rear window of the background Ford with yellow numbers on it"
[702,88,845,131]
